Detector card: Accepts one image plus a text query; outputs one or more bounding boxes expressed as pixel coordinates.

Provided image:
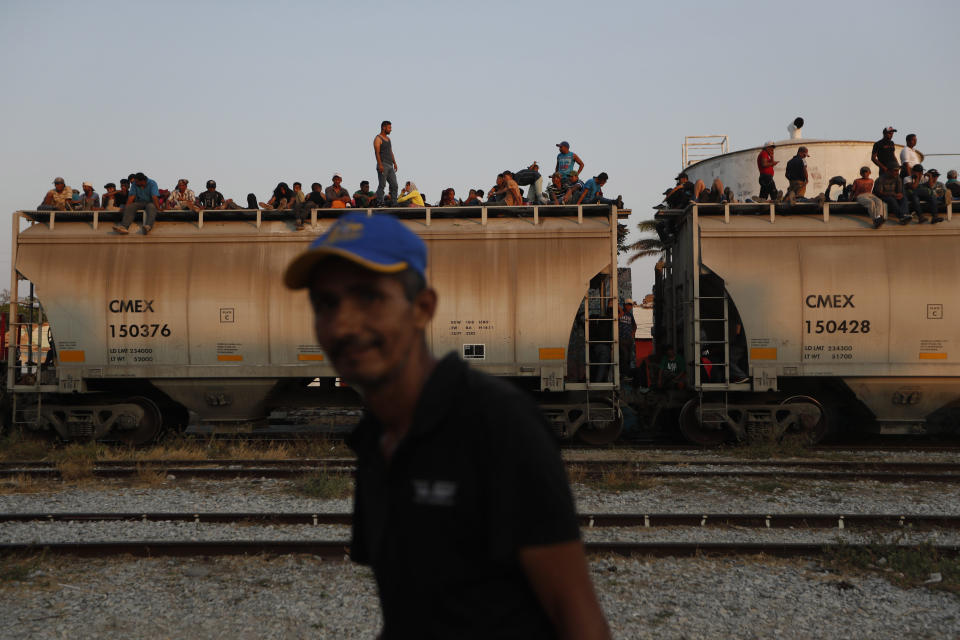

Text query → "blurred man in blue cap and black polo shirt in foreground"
[284,212,609,639]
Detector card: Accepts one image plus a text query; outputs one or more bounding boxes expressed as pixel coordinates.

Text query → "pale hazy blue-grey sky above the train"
[0,0,960,296]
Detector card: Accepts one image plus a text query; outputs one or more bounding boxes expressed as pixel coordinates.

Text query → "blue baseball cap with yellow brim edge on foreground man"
[283,212,427,289]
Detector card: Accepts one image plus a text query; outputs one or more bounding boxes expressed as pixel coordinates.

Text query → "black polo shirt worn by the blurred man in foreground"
[348,354,580,638]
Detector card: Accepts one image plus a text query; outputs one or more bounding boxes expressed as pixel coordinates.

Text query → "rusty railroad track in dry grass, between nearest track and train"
[0,458,960,483]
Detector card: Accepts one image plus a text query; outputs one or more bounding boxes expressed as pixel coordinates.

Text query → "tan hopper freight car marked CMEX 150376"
[6,205,629,443]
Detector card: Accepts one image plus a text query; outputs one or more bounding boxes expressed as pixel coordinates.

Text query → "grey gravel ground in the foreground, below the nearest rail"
[0,556,960,640]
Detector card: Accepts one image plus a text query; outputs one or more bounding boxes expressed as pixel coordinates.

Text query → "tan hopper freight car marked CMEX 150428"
[655,202,960,444]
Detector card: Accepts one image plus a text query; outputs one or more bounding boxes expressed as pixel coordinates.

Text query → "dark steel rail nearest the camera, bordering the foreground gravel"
[0,540,960,560]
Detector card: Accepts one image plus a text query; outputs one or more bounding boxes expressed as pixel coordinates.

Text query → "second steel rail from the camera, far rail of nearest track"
[0,511,960,531]
